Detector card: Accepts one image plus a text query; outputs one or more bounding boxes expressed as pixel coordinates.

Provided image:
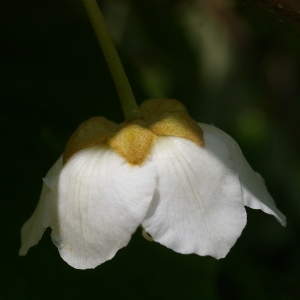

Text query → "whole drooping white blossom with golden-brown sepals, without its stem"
[20,99,286,269]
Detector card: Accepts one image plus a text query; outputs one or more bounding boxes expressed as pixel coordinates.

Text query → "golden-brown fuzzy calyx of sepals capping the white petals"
[63,99,204,165]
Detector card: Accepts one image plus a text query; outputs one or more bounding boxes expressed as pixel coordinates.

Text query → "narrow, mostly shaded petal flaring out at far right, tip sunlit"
[199,123,286,226]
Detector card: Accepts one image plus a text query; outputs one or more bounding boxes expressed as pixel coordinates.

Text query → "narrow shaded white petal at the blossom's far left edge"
[19,157,62,255]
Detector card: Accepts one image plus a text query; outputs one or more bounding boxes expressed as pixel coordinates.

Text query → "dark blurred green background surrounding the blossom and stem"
[0,0,300,300]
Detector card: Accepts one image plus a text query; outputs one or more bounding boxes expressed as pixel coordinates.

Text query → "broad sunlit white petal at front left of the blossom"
[51,146,156,269]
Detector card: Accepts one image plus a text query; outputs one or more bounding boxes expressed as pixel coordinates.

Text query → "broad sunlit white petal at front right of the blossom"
[142,133,246,258]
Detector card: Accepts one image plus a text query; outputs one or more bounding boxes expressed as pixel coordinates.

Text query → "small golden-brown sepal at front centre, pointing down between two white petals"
[108,124,156,165]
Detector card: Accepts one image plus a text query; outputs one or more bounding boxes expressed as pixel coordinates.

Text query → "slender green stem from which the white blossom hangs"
[82,0,140,122]
